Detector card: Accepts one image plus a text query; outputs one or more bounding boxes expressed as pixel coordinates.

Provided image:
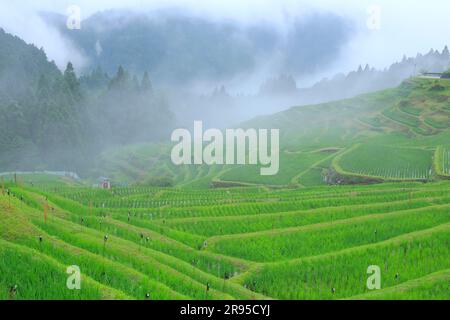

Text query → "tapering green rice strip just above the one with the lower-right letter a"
[209,205,450,262]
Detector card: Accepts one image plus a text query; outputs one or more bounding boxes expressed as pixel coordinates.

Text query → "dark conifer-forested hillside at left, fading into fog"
[0,29,172,172]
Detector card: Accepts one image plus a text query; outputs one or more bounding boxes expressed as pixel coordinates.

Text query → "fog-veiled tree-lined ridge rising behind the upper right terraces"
[169,46,450,127]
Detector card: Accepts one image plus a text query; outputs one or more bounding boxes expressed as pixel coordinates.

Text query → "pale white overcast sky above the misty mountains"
[0,0,450,72]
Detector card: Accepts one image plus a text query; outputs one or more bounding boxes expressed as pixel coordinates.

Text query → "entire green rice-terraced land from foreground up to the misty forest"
[0,79,450,300]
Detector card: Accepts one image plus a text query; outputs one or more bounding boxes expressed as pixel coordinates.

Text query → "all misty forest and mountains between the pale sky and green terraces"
[0,2,450,171]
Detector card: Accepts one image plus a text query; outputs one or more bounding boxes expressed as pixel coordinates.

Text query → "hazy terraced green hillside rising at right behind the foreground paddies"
[93,78,450,188]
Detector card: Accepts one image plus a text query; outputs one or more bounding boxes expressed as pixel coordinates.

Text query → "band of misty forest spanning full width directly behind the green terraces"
[0,22,450,172]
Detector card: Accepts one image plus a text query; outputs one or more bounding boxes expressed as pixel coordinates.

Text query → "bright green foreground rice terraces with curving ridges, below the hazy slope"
[0,181,450,299]
